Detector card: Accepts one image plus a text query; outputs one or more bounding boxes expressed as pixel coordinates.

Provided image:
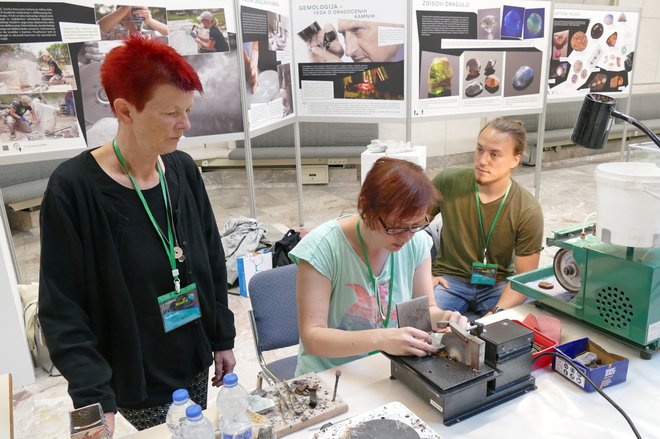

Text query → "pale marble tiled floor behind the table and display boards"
[7,149,655,439]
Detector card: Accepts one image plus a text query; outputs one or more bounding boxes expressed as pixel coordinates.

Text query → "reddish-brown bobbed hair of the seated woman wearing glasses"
[358,157,439,228]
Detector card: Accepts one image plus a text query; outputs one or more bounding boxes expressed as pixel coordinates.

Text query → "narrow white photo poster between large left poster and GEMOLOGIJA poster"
[240,0,294,129]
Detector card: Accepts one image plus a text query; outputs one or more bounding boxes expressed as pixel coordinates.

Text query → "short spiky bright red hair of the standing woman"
[101,37,202,112]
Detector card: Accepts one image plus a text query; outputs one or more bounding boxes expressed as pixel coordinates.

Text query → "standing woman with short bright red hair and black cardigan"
[39,38,236,429]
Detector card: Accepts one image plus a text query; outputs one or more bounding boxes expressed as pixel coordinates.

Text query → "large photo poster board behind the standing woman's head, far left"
[0,0,243,164]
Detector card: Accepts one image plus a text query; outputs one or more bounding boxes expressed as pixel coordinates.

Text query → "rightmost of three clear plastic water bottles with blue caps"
[217,373,252,439]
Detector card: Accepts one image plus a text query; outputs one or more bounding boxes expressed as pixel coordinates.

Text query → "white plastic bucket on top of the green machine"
[596,162,660,247]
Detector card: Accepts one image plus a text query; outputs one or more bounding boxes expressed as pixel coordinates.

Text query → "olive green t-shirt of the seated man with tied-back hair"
[433,168,543,282]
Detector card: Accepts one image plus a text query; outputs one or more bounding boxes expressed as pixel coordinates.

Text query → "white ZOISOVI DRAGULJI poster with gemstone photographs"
[411,0,550,117]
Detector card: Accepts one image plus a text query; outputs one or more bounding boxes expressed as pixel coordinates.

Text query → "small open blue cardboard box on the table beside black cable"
[552,338,629,392]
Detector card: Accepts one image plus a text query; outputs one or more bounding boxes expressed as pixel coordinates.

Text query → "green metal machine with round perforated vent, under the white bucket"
[509,225,660,359]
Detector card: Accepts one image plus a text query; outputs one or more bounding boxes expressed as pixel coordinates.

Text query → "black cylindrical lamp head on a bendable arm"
[571,93,616,149]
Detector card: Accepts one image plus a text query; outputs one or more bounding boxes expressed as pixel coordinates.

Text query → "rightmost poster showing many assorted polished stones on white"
[548,5,639,101]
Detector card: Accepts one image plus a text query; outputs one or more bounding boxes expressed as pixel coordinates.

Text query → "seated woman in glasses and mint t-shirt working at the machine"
[289,157,466,376]
